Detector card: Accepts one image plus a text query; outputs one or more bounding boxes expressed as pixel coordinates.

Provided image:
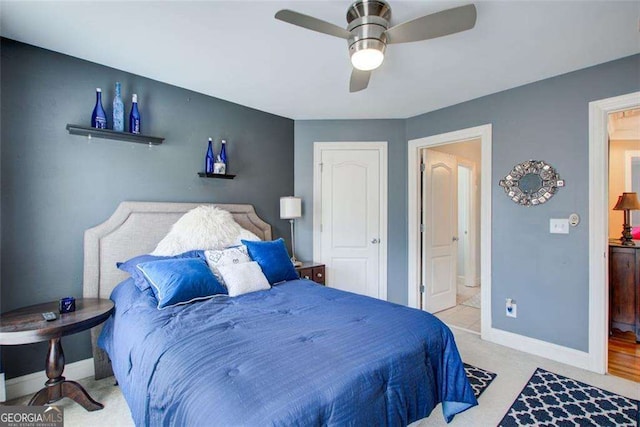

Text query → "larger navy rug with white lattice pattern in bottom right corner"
[499,368,640,427]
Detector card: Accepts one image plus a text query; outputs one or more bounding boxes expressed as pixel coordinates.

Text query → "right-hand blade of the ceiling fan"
[385,4,477,44]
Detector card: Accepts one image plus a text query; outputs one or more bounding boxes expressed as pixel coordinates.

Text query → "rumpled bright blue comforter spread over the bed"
[99,279,477,426]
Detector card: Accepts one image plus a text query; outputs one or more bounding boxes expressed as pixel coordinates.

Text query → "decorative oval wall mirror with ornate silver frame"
[500,160,564,206]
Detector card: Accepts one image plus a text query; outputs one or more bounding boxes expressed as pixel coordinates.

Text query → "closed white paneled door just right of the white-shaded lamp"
[314,146,386,299]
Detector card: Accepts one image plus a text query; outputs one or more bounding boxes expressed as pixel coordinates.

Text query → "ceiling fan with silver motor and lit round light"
[275,0,476,92]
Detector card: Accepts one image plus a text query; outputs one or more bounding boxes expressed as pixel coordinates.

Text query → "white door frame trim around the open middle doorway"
[407,124,491,338]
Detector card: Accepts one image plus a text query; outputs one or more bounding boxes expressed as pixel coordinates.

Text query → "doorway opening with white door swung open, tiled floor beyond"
[422,142,482,334]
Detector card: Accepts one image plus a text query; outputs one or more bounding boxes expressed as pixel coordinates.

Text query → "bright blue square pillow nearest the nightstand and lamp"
[241,238,299,285]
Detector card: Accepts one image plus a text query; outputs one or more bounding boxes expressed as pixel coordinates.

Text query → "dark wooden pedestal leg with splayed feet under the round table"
[29,338,104,411]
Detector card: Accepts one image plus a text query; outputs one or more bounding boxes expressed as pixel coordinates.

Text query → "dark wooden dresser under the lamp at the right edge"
[609,243,640,341]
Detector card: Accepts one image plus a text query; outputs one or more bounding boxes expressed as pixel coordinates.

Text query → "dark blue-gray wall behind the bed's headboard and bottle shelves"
[0,39,294,378]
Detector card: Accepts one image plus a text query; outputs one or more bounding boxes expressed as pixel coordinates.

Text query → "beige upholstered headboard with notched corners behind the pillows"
[83,202,271,378]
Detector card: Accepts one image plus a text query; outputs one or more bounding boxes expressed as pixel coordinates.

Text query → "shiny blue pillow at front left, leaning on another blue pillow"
[138,258,227,308]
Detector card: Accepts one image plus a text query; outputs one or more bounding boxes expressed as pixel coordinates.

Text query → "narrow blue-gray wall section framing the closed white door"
[295,120,407,304]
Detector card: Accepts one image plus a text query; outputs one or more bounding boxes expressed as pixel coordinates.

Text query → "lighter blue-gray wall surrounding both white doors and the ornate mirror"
[295,55,640,351]
